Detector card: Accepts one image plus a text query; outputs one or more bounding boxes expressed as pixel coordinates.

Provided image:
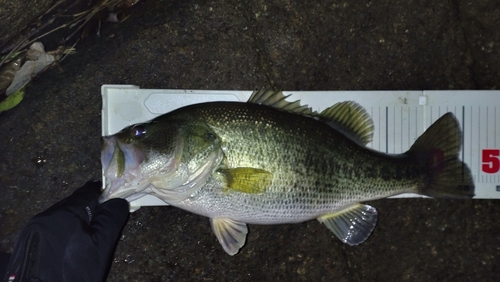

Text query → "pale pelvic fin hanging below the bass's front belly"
[210,218,248,256]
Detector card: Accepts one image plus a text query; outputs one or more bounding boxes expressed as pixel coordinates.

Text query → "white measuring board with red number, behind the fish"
[101,85,500,209]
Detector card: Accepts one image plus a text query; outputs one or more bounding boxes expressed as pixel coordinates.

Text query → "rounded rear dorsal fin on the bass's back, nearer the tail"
[319,101,373,145]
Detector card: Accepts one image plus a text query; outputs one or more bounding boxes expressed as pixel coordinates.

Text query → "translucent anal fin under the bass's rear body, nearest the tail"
[318,204,377,246]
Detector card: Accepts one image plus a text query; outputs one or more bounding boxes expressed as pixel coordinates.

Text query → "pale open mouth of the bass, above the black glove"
[99,136,150,203]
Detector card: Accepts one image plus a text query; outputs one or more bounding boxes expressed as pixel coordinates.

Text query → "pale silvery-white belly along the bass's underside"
[173,176,400,224]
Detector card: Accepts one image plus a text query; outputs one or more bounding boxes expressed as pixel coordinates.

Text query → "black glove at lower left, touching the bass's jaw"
[0,182,129,282]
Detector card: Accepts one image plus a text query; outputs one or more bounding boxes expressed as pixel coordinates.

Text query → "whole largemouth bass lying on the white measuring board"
[101,90,474,255]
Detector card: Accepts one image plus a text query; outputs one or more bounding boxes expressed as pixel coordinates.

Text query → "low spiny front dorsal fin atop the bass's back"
[248,89,313,115]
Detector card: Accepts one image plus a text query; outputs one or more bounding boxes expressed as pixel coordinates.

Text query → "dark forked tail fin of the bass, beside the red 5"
[407,113,475,198]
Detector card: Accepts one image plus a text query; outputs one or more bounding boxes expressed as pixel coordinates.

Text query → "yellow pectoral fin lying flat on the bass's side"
[217,167,273,194]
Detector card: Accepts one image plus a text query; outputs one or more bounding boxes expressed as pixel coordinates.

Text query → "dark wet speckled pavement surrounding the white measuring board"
[0,0,500,281]
